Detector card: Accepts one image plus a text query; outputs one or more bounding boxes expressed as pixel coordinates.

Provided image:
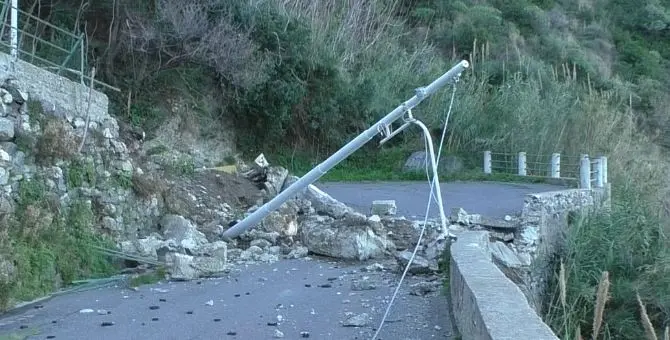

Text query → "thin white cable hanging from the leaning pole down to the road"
[372,82,456,340]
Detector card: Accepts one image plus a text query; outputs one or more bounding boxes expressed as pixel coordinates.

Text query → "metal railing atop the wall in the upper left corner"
[0,0,120,92]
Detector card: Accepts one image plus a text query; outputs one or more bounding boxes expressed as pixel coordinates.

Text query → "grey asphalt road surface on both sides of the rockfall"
[0,183,568,340]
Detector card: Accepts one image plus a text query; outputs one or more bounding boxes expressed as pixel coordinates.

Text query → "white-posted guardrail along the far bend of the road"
[484,151,607,189]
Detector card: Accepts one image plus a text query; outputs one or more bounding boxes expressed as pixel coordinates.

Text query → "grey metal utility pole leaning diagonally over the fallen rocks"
[222,60,470,238]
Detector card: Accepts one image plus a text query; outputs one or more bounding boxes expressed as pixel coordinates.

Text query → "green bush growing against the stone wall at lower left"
[0,179,115,307]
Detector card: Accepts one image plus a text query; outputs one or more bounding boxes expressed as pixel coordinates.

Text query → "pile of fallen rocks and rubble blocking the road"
[121,155,532,280]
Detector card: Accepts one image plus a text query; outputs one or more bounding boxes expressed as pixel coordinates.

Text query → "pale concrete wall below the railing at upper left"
[0,53,109,122]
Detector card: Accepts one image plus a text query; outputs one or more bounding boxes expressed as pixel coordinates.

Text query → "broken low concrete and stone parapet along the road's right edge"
[450,187,610,340]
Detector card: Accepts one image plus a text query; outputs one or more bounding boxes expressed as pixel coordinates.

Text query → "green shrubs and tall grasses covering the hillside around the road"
[10,0,670,338]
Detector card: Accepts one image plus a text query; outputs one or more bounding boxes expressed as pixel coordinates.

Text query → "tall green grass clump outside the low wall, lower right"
[546,187,670,339]
